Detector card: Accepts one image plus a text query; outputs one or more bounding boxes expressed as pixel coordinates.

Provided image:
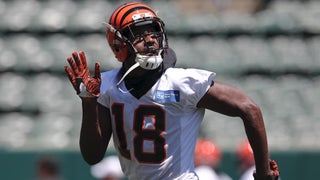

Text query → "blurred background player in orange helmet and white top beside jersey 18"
[194,138,232,180]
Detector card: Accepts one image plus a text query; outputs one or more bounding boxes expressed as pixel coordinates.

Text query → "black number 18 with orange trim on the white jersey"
[111,103,166,163]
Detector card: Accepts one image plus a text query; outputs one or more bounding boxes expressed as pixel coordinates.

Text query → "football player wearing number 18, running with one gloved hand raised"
[65,2,280,180]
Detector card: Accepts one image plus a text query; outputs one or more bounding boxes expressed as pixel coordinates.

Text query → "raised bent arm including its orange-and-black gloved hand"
[64,51,111,164]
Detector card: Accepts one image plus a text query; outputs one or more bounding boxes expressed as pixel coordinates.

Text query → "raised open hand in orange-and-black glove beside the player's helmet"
[64,51,101,97]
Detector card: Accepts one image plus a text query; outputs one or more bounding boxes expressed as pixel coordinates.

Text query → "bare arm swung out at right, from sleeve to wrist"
[197,82,272,180]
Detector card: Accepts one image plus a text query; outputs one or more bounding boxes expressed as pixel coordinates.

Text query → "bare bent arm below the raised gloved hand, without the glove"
[80,98,112,165]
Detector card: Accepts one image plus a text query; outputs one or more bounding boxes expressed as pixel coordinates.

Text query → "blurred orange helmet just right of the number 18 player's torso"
[194,138,222,167]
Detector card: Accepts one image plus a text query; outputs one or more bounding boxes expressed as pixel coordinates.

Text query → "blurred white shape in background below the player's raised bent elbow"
[91,155,124,180]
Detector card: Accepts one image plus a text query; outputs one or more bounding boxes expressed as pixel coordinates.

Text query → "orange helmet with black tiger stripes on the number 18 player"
[106,2,167,62]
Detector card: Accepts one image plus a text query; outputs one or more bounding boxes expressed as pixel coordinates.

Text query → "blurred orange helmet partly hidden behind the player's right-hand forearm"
[236,140,254,169]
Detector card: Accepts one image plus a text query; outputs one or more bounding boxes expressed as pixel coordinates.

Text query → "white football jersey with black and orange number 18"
[98,68,215,180]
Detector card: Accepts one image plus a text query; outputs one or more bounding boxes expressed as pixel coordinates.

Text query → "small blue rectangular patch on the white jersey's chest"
[155,90,180,103]
